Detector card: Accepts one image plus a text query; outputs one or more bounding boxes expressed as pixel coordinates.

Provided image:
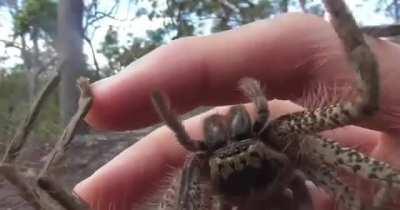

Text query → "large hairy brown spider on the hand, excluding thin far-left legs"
[152,0,400,210]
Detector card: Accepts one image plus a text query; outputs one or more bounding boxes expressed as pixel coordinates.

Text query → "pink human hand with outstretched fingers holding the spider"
[75,14,400,210]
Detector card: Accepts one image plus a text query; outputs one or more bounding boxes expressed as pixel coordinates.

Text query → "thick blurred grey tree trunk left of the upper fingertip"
[56,0,86,124]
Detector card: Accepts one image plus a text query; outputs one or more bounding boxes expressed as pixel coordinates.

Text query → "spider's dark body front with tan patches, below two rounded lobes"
[209,140,282,196]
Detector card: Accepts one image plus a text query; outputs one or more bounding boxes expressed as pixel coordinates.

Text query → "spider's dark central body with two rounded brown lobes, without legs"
[200,92,289,197]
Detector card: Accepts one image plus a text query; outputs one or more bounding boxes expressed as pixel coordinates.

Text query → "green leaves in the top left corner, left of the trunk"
[14,0,57,38]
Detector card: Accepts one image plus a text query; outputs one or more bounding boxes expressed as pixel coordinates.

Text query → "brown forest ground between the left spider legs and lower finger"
[0,127,154,210]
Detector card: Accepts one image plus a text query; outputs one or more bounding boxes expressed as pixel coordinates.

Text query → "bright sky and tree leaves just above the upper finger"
[98,0,296,72]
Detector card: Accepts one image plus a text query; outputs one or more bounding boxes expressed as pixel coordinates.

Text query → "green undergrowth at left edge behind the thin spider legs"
[0,69,61,141]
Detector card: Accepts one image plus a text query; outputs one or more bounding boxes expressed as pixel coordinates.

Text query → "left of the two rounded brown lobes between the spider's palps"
[204,114,229,150]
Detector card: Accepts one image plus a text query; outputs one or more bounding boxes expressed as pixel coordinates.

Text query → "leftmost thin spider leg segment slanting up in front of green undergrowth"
[2,71,60,163]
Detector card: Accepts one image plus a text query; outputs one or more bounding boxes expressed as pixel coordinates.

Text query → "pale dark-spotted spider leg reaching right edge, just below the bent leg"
[300,135,400,190]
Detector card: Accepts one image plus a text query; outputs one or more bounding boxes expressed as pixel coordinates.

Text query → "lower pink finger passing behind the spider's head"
[74,100,373,210]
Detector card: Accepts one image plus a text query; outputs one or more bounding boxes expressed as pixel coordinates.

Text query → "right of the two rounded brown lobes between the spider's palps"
[229,106,252,141]
